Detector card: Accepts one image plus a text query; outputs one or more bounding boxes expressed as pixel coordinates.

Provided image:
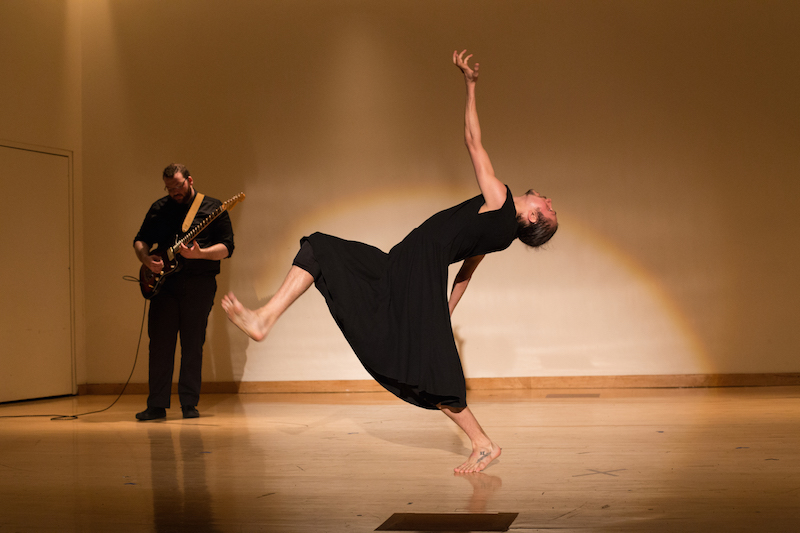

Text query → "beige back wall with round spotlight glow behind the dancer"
[0,0,800,383]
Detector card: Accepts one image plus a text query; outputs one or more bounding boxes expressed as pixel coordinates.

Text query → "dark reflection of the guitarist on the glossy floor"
[148,424,219,533]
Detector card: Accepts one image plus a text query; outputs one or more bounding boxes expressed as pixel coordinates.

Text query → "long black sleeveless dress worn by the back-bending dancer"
[301,187,517,409]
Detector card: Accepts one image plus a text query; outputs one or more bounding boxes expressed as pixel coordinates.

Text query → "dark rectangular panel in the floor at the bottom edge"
[375,513,519,532]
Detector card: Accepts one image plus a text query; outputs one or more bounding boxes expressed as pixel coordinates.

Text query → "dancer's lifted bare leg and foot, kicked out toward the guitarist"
[222,265,314,341]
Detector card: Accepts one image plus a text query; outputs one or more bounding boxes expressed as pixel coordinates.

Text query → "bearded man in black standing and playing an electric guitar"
[133,164,234,420]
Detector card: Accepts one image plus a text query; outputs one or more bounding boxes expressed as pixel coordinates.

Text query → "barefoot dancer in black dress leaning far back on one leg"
[222,51,558,472]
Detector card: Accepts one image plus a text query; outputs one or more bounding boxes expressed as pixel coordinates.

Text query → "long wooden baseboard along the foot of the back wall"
[78,372,800,395]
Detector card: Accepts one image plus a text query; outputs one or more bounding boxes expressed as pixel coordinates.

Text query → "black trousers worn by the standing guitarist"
[147,272,217,409]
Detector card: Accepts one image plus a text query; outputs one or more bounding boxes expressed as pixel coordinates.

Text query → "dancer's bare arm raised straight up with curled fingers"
[453,50,506,211]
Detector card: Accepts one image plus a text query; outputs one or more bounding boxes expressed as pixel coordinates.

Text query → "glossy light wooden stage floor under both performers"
[0,387,800,533]
